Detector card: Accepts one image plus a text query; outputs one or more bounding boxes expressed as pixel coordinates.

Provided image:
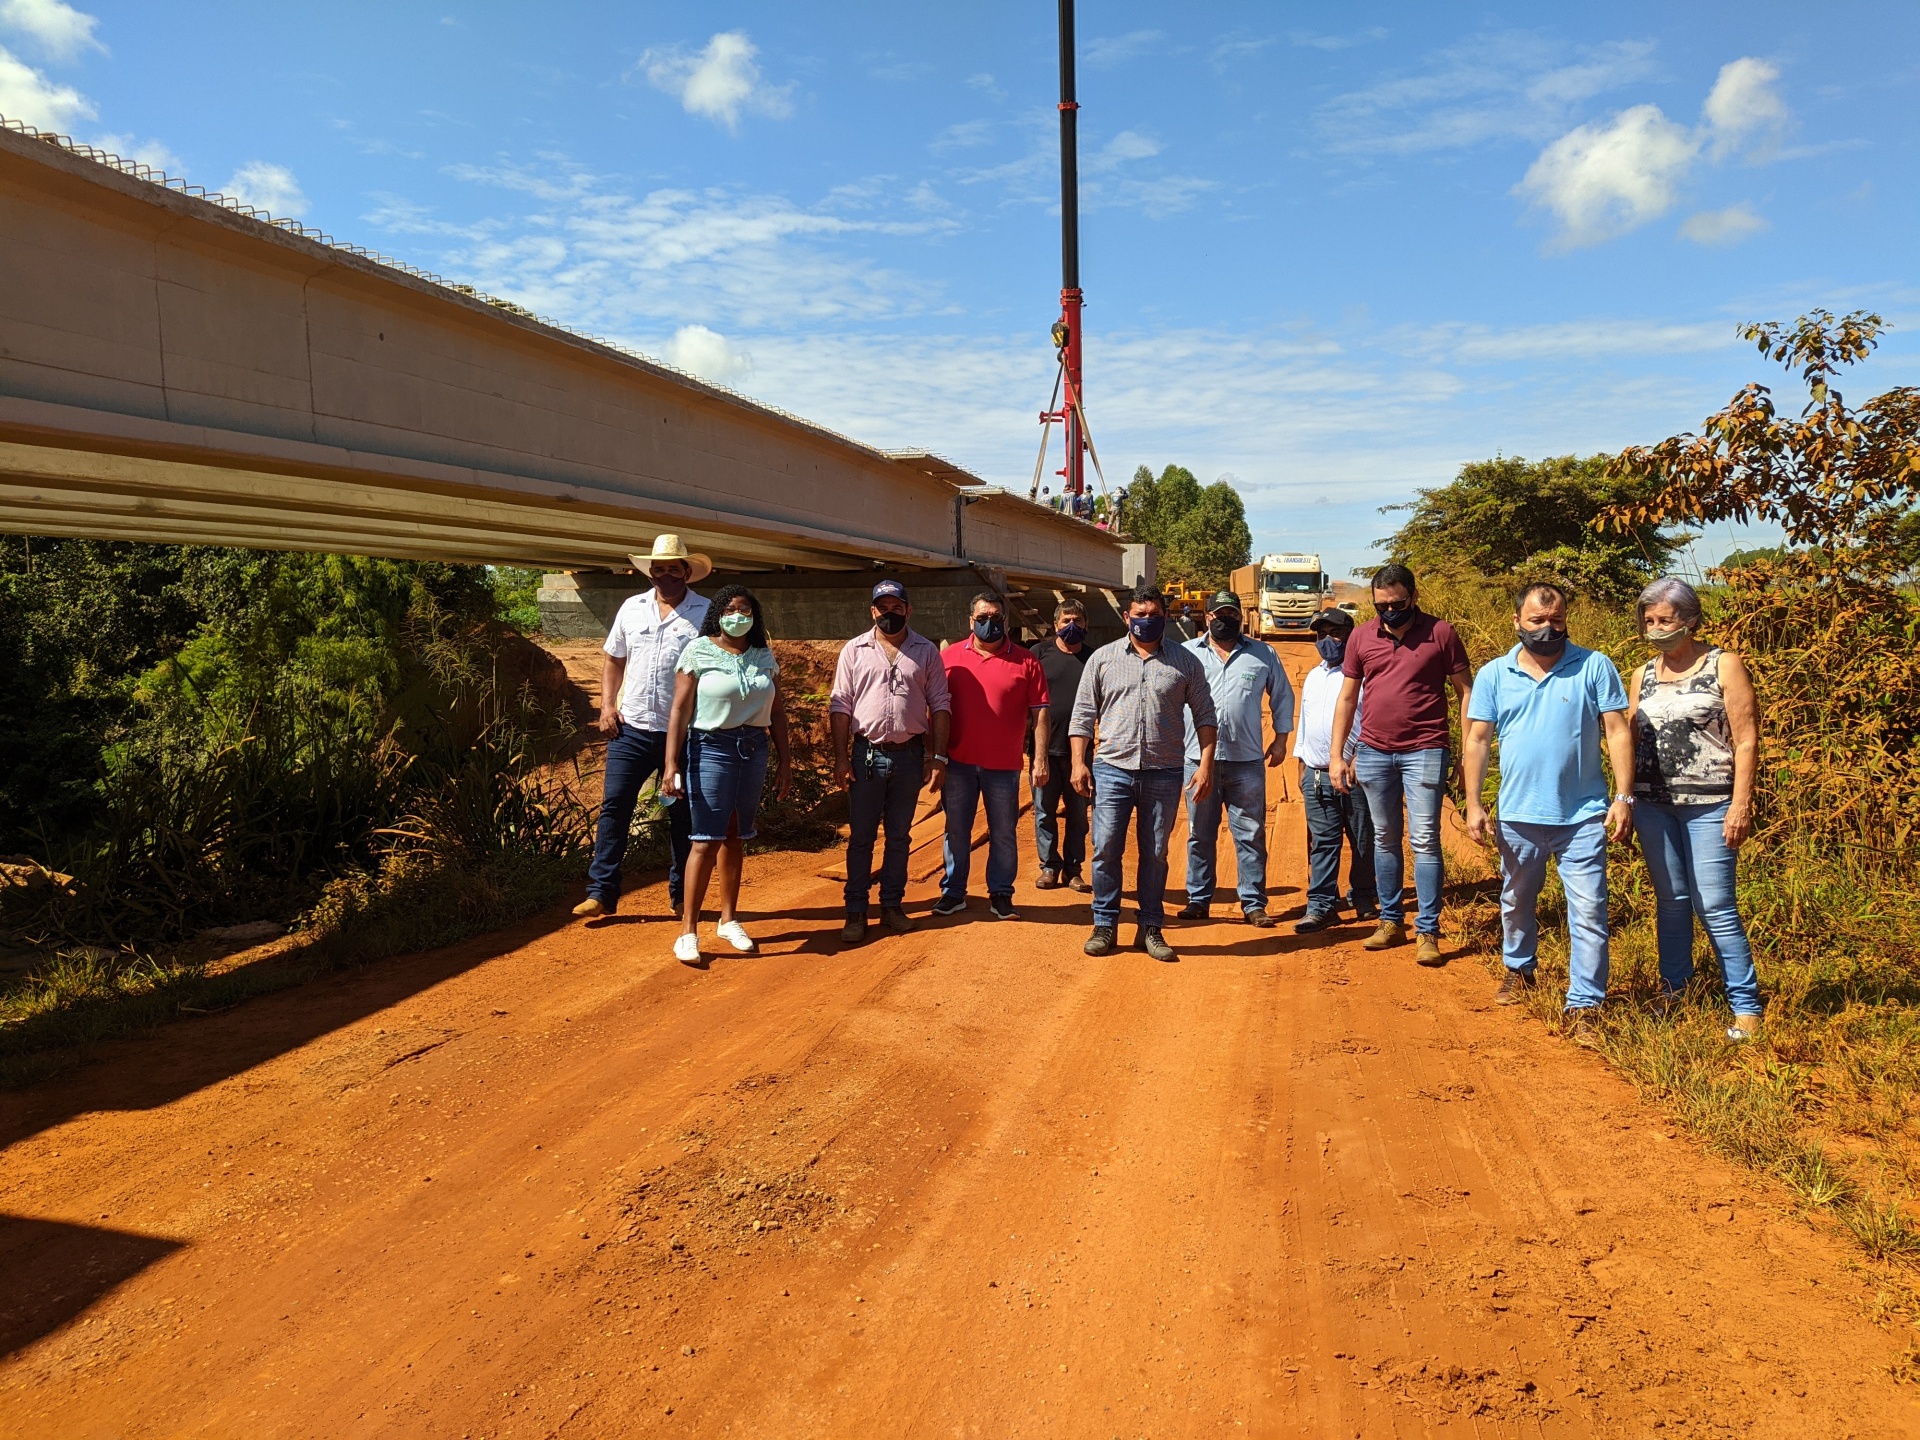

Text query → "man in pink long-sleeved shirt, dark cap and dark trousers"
[828,580,952,945]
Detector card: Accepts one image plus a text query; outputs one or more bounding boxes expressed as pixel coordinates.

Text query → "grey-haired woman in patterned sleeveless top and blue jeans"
[1628,580,1761,1041]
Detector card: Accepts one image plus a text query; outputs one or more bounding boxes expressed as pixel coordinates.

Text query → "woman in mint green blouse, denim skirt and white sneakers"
[660,586,793,970]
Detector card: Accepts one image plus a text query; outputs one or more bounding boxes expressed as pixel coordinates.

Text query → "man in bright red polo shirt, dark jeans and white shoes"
[933,593,1048,920]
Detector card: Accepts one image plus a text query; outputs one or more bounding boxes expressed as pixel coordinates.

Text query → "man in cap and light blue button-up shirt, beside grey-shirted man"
[1181,589,1294,929]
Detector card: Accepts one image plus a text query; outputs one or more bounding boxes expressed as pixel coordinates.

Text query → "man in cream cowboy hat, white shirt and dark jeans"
[574,536,714,920]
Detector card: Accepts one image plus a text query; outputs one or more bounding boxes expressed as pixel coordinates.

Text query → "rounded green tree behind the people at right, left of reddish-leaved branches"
[1375,455,1688,601]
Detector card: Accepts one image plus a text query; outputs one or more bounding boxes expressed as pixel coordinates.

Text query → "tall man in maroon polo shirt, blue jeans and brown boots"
[1327,564,1473,966]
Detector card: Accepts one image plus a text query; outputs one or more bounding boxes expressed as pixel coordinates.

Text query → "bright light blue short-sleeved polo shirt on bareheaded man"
[1467,641,1626,826]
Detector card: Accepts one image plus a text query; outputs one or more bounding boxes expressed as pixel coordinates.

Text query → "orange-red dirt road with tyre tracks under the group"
[0,653,1920,1440]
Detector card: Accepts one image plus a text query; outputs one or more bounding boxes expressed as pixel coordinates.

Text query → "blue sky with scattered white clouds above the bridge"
[0,0,1920,570]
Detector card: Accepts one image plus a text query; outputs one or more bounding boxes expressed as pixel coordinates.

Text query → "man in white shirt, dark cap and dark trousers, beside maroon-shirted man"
[1294,611,1380,935]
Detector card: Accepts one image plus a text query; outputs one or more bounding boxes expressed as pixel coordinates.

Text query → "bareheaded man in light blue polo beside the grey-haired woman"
[1461,584,1634,1043]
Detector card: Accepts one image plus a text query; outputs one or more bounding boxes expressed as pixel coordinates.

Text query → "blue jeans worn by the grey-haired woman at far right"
[1634,801,1761,1016]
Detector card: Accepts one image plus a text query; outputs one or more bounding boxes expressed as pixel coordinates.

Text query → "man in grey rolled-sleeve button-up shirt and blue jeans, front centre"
[1068,586,1215,960]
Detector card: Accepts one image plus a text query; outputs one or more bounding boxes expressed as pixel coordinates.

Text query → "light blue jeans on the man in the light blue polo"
[1494,816,1607,1010]
